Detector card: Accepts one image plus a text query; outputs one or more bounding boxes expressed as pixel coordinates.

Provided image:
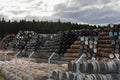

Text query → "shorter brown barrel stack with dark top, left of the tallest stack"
[62,30,99,60]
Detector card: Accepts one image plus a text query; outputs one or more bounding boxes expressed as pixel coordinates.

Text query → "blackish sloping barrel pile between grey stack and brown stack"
[59,30,80,56]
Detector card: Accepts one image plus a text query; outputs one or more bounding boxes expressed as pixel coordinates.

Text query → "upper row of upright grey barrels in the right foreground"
[68,60,119,74]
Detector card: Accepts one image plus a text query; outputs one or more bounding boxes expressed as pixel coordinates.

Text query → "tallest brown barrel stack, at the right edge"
[97,24,120,59]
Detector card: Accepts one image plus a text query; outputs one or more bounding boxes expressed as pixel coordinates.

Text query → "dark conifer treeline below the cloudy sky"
[0,18,101,37]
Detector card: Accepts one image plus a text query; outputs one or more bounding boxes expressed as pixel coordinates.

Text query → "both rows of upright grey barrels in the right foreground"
[53,60,120,80]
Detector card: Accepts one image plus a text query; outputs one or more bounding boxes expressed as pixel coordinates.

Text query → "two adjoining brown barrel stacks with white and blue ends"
[62,24,120,60]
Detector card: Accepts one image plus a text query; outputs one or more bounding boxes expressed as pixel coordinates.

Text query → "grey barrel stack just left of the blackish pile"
[35,33,61,59]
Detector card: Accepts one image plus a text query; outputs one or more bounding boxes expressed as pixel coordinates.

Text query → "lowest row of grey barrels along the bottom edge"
[52,70,120,80]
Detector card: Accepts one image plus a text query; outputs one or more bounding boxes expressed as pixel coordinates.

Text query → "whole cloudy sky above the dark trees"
[0,0,120,24]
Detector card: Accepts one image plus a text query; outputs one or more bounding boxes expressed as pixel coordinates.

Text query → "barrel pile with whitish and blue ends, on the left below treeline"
[12,31,40,51]
